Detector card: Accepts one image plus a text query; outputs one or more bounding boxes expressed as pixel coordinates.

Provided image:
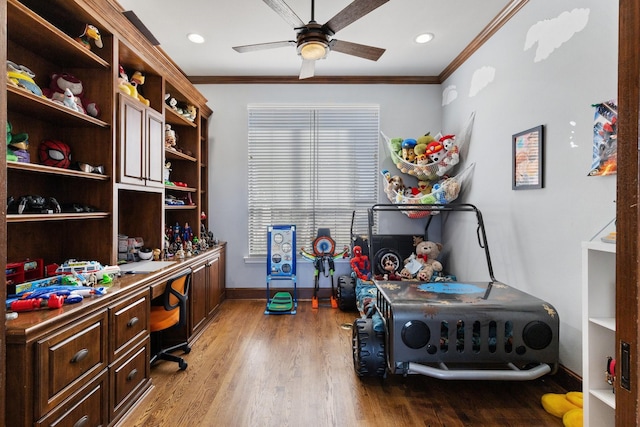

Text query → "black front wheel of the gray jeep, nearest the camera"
[351,318,387,377]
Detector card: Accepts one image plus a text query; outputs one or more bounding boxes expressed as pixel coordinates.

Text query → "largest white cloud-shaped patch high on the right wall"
[524,9,589,62]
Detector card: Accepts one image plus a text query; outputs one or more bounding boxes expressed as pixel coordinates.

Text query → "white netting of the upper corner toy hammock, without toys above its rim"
[380,112,475,181]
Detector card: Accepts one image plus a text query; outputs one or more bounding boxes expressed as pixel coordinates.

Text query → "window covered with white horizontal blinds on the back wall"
[248,105,380,257]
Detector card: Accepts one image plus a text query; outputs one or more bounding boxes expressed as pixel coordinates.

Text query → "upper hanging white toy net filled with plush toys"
[380,112,475,181]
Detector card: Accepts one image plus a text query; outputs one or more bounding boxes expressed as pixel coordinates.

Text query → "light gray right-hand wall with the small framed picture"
[442,0,618,374]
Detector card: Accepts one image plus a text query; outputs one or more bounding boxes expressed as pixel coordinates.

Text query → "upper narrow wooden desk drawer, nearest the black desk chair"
[109,289,151,362]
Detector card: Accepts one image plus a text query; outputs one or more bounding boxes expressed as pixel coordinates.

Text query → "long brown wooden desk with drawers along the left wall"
[5,244,225,426]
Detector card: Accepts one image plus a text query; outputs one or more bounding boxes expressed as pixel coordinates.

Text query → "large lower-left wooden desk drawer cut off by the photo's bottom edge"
[36,371,109,427]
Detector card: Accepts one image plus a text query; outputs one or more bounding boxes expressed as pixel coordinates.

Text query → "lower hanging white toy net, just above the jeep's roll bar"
[383,163,475,218]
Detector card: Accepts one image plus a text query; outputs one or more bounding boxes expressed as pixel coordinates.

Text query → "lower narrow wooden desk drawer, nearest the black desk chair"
[109,340,150,422]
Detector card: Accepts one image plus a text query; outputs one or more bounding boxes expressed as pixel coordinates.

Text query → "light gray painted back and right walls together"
[198,0,617,375]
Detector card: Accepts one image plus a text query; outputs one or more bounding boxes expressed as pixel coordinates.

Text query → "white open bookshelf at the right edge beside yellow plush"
[582,240,616,427]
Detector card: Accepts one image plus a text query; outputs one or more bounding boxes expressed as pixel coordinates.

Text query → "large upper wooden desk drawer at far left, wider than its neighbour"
[35,310,107,418]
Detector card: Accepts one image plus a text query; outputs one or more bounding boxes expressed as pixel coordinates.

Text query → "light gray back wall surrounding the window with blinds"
[198,85,442,288]
